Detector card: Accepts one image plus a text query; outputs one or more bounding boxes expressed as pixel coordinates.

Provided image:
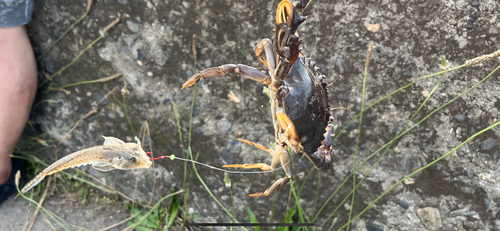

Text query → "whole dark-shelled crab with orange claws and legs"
[182,0,333,197]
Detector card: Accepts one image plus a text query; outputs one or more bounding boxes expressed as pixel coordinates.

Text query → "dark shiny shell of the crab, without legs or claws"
[277,53,332,170]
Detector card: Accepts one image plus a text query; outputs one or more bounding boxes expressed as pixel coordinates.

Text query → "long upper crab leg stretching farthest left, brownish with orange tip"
[182,64,271,89]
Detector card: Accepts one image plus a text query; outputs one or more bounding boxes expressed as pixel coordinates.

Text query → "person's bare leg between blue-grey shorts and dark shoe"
[0,26,38,185]
